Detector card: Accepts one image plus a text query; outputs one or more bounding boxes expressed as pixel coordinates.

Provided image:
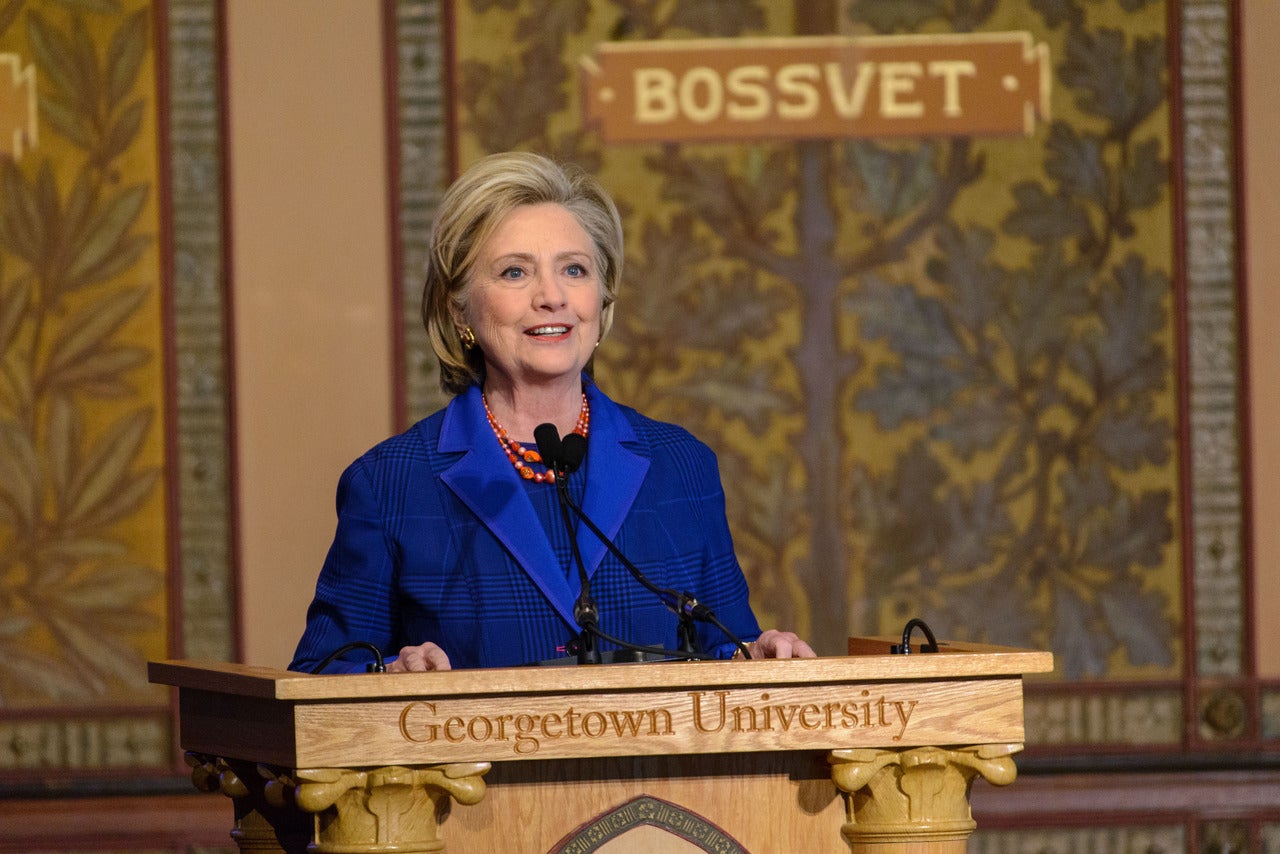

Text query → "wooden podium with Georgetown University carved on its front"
[150,639,1052,854]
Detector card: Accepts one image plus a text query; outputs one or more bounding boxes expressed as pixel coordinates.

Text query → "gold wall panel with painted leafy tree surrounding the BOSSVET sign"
[453,0,1184,680]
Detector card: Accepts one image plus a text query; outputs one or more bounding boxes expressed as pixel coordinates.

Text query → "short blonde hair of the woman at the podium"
[422,151,622,394]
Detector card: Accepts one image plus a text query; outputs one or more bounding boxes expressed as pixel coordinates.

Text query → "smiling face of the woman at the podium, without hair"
[463,204,603,388]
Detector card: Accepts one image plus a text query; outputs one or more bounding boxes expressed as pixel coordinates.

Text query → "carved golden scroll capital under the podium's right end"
[828,744,1023,851]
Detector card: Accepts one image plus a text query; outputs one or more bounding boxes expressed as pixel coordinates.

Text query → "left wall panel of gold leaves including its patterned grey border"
[0,0,236,782]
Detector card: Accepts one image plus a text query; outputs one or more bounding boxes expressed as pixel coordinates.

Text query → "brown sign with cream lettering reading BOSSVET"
[580,32,1051,142]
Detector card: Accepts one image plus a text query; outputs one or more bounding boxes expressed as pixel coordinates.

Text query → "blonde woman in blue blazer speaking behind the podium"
[291,154,813,671]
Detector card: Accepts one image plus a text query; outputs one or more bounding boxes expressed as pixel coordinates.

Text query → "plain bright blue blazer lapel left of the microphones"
[439,385,581,625]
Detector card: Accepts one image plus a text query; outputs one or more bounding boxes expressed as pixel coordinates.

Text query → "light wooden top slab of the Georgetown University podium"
[148,638,1053,703]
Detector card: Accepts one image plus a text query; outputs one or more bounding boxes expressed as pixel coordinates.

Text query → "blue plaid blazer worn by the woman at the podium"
[289,382,760,672]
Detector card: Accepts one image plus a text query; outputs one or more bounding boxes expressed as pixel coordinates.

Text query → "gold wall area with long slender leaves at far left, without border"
[0,0,169,711]
